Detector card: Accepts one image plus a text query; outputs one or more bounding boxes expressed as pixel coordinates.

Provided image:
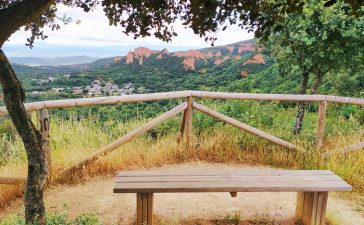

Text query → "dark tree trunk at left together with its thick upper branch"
[0,0,55,225]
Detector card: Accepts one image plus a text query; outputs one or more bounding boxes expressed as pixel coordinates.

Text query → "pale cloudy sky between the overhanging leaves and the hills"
[3,6,254,58]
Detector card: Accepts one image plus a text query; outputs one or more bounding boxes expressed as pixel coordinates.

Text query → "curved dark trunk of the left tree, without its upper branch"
[0,49,48,224]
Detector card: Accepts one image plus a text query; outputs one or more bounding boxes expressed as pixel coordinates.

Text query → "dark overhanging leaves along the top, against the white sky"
[0,0,364,47]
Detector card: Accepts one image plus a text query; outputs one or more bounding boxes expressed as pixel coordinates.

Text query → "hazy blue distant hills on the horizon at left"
[10,56,99,66]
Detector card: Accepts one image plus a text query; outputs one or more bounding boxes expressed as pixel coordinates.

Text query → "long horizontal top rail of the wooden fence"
[0,91,364,116]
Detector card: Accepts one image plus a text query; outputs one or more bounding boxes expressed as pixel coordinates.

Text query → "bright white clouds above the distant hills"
[6,7,253,51]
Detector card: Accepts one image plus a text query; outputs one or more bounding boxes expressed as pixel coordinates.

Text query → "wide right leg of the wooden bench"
[296,192,328,225]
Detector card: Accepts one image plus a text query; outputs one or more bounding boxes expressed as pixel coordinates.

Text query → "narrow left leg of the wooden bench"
[136,193,153,225]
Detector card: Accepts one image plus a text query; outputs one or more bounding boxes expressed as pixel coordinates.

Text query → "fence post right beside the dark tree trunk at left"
[39,108,52,175]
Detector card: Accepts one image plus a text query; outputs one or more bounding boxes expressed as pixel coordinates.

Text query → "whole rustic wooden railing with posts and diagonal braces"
[0,91,364,184]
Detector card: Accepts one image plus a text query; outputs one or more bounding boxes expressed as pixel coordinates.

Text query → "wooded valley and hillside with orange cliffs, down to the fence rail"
[8,40,364,101]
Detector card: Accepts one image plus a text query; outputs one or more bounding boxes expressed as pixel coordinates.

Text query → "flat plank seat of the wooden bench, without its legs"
[114,169,352,193]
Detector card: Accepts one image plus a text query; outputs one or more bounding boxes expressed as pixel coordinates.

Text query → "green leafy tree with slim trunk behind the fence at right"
[261,0,364,134]
